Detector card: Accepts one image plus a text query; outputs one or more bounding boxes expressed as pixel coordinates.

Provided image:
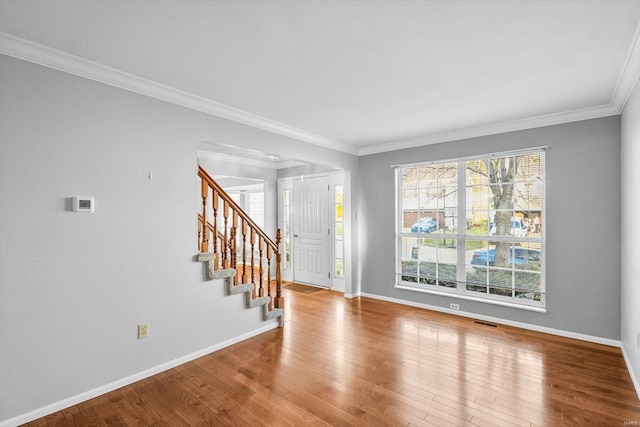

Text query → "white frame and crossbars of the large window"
[392,147,548,313]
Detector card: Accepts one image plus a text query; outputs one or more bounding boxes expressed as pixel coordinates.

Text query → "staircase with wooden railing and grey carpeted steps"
[196,167,284,327]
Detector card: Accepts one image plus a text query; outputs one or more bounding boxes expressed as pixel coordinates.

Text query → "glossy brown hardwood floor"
[22,288,640,426]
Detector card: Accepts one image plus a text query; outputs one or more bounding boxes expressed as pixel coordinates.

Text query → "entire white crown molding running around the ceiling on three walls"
[0,27,640,160]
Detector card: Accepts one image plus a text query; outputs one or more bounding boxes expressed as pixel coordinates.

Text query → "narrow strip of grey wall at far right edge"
[621,78,640,396]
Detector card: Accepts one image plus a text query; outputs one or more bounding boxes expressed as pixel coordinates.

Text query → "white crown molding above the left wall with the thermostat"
[0,32,357,155]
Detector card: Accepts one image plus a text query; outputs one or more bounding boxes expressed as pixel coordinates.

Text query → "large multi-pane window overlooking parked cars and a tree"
[396,150,545,307]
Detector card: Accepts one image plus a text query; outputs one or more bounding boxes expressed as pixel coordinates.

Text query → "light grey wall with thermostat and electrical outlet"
[0,56,357,420]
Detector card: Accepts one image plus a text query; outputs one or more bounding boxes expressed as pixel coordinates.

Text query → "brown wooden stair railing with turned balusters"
[198,167,284,310]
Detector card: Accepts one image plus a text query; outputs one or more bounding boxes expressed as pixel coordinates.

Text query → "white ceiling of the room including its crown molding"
[0,0,640,154]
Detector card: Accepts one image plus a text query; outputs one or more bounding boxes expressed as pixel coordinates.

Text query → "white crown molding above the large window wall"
[358,104,620,156]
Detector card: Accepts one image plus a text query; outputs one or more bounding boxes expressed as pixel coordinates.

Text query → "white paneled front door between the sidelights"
[293,176,331,287]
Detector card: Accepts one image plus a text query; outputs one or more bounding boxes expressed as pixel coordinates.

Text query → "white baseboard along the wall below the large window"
[362,292,622,348]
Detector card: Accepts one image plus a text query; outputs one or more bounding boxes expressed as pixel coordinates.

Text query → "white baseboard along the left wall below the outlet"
[0,321,278,427]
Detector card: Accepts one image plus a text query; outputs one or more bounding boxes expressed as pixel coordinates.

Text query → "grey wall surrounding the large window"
[359,116,620,340]
